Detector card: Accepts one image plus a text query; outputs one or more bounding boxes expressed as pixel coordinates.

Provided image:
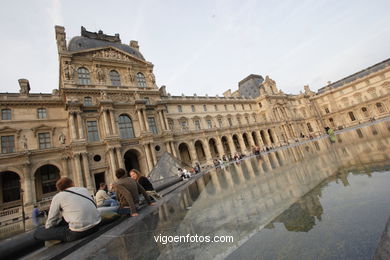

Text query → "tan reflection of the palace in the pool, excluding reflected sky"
[79,122,390,259]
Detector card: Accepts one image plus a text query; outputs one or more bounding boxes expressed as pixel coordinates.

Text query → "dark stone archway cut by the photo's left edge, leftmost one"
[0,171,21,207]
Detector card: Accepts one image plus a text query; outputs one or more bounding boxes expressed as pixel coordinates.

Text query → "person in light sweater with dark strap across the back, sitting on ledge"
[34,177,101,242]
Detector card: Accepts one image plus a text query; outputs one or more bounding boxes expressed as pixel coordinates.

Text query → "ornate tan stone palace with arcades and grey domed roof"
[0,26,390,218]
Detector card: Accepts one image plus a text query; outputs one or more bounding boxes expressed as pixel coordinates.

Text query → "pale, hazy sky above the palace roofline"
[0,0,390,95]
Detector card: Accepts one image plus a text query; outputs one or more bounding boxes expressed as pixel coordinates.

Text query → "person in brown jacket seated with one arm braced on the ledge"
[115,168,156,217]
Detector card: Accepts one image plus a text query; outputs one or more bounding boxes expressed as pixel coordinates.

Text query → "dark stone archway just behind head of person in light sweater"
[34,164,60,201]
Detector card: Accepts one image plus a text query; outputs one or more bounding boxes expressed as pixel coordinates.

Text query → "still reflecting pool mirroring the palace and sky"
[56,121,390,259]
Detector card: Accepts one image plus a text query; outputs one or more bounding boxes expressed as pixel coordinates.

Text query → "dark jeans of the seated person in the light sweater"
[34,221,99,242]
